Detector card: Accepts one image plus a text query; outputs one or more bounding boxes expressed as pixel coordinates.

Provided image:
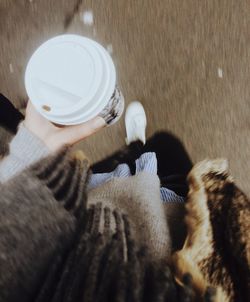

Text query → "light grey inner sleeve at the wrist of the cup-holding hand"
[0,123,50,183]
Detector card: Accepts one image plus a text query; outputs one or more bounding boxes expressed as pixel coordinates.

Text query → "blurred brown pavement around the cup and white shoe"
[0,0,250,193]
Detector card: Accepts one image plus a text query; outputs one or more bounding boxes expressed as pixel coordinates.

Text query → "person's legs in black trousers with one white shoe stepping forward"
[92,101,192,196]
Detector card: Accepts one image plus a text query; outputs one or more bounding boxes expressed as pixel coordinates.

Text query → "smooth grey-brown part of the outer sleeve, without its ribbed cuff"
[0,153,81,302]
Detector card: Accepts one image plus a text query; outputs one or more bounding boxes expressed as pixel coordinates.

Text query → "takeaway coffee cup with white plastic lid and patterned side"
[25,35,124,125]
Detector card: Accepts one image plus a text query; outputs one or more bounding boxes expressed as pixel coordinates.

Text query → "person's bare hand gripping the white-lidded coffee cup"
[24,101,106,151]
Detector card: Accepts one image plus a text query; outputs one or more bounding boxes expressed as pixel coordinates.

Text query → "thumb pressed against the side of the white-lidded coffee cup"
[58,116,106,145]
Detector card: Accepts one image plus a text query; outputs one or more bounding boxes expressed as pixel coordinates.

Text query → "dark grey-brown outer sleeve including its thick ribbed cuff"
[0,148,88,302]
